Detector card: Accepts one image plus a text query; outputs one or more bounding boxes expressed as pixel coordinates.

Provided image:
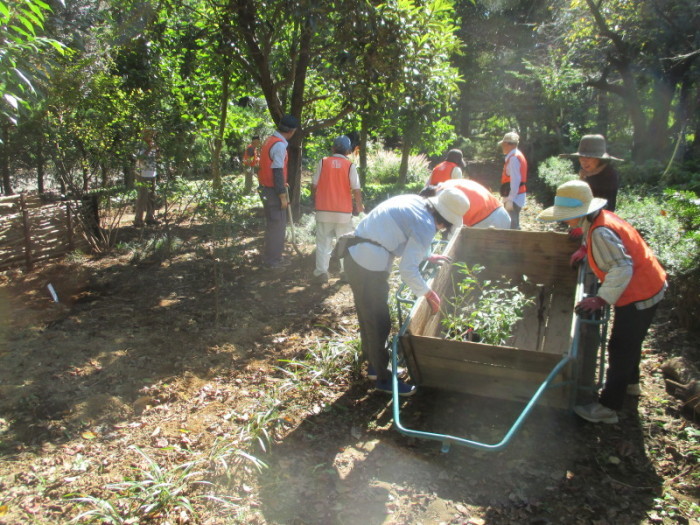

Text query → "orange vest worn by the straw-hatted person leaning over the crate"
[586,210,666,306]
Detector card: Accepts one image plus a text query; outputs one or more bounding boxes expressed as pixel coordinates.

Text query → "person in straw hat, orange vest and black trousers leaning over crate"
[537,180,668,423]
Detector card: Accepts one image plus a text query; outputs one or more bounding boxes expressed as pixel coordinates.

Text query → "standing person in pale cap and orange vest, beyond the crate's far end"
[500,131,527,230]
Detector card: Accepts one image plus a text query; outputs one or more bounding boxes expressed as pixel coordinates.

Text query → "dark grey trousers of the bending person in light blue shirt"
[344,254,391,381]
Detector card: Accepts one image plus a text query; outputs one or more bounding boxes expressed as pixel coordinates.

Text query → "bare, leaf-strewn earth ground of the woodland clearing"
[0,198,700,525]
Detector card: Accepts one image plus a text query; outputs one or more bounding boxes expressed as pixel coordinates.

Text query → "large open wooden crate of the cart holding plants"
[401,228,577,407]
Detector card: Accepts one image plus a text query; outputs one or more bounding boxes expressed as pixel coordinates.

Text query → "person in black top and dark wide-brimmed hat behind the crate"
[559,135,622,217]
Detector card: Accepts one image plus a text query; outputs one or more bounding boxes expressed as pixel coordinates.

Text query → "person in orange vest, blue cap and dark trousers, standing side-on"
[258,115,299,270]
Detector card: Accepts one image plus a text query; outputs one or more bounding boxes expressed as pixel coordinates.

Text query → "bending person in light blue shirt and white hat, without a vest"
[344,188,469,396]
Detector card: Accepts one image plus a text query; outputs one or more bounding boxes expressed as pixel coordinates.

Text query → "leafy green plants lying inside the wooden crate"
[440,263,534,346]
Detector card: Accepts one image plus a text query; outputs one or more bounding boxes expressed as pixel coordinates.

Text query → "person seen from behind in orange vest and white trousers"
[311,135,364,283]
